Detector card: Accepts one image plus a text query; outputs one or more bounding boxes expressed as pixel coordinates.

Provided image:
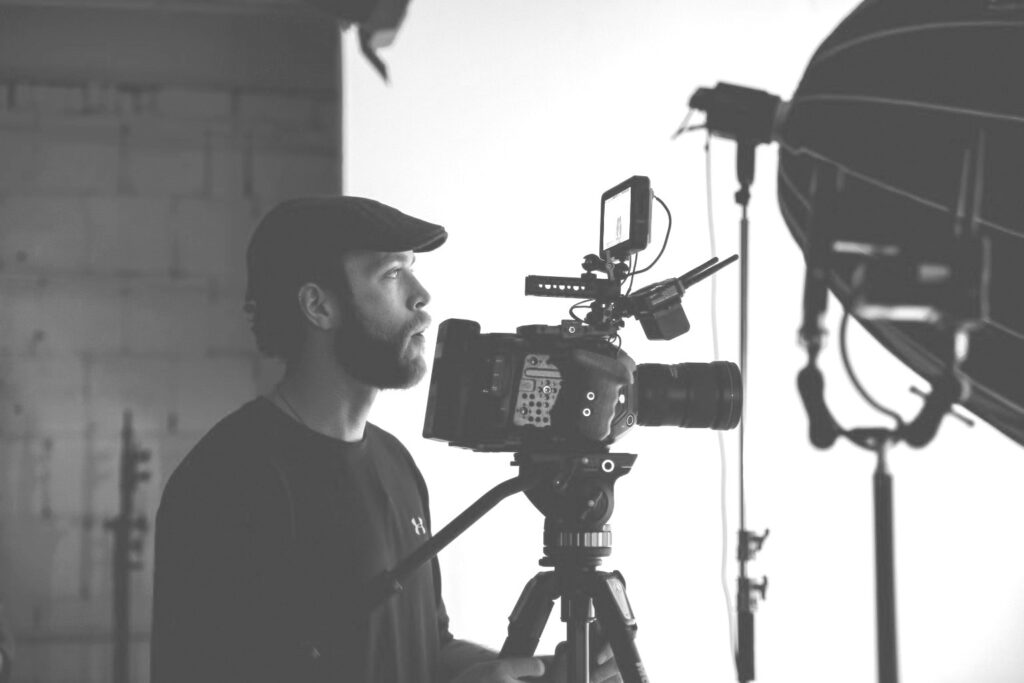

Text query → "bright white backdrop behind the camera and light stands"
[345,0,1024,683]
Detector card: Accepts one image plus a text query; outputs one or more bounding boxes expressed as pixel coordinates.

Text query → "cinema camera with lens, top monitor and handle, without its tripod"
[423,176,742,454]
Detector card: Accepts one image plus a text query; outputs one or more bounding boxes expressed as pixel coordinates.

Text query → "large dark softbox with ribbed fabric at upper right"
[778,0,1024,444]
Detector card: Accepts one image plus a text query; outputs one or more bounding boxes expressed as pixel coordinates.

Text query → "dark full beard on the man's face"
[334,300,429,389]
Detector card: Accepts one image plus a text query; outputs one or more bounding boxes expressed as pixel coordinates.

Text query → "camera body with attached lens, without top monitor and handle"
[423,319,742,455]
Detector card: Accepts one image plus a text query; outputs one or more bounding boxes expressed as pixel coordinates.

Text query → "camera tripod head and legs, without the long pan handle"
[501,454,648,683]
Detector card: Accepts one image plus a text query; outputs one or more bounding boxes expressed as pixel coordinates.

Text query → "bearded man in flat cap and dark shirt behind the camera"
[152,197,618,683]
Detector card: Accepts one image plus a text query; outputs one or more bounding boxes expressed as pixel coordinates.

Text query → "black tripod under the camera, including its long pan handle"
[360,452,649,683]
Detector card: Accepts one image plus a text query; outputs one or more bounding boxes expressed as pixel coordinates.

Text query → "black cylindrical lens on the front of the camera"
[635,360,743,429]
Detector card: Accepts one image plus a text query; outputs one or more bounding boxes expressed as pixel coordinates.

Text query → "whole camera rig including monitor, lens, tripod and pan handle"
[415,176,742,683]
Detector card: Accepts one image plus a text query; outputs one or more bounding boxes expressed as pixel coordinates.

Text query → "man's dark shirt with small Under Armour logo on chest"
[152,398,452,683]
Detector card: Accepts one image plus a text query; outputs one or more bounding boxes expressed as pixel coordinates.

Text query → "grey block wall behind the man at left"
[0,5,340,683]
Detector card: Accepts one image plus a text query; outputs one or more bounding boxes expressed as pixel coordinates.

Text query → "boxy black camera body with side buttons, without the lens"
[423,319,638,453]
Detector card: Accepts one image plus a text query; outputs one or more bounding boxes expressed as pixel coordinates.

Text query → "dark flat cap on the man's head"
[246,197,447,301]
